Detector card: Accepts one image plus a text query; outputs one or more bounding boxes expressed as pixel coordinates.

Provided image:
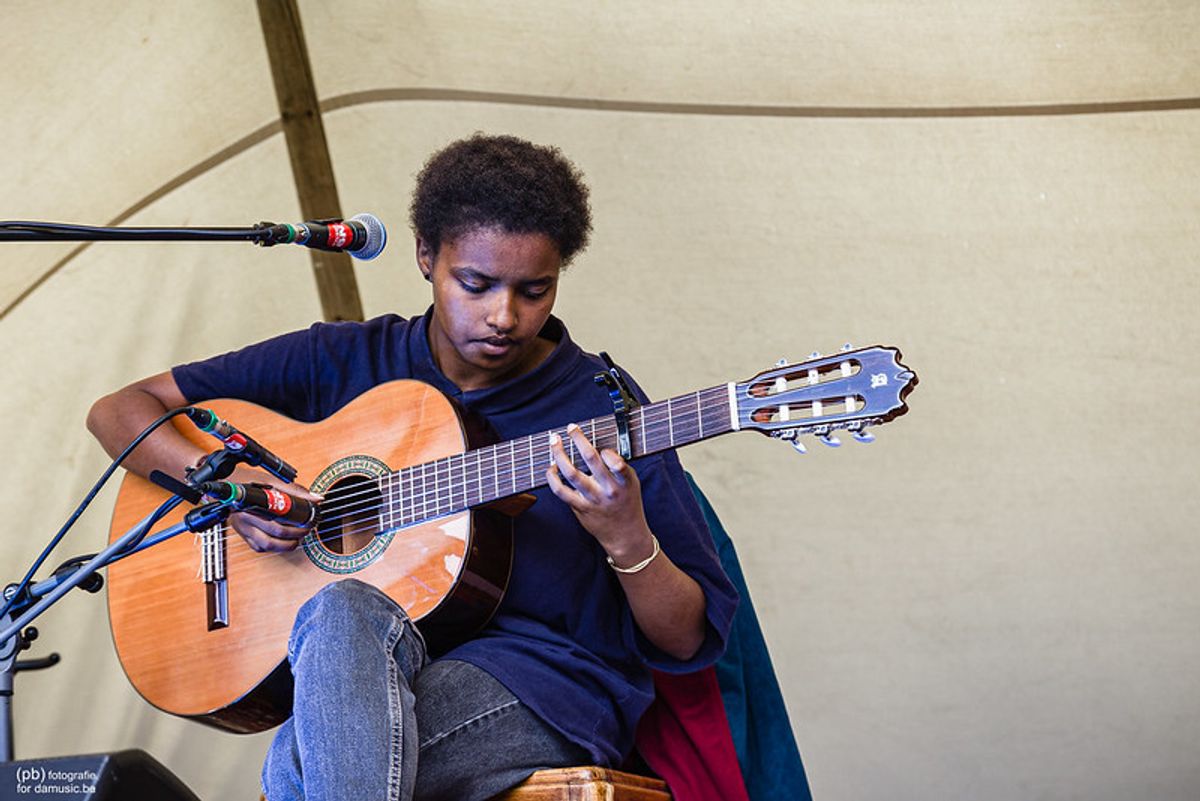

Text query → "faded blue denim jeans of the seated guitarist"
[263,579,589,801]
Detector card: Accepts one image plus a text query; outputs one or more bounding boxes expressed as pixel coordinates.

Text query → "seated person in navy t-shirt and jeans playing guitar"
[88,134,737,801]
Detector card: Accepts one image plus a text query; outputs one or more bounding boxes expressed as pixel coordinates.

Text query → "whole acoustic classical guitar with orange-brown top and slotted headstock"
[108,347,917,733]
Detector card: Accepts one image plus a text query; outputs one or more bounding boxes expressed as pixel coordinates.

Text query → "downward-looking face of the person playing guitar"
[416,228,563,391]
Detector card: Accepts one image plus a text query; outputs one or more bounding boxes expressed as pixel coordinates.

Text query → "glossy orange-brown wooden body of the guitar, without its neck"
[108,380,512,733]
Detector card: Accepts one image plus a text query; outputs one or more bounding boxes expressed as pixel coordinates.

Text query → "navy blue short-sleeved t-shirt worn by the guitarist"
[173,312,737,765]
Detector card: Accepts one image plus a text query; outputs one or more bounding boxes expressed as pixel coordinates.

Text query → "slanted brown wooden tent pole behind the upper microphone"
[258,0,362,320]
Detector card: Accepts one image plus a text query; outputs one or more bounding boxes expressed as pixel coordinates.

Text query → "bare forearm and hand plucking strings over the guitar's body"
[88,372,320,550]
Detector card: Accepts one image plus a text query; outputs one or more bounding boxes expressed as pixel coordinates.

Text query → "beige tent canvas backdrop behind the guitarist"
[0,0,1200,800]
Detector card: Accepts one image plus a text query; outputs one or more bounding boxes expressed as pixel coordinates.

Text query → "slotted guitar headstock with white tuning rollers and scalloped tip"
[731,345,917,452]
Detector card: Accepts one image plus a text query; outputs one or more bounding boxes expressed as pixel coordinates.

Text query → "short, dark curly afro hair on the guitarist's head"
[409,133,592,265]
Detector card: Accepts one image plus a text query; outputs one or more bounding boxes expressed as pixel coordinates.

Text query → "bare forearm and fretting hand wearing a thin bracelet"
[546,426,706,660]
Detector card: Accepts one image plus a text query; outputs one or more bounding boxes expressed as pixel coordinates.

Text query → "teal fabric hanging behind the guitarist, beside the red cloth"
[688,475,812,801]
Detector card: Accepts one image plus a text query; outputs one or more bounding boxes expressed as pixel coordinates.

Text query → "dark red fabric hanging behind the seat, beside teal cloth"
[637,668,749,801]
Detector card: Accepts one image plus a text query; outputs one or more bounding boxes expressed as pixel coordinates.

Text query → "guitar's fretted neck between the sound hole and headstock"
[379,384,734,528]
